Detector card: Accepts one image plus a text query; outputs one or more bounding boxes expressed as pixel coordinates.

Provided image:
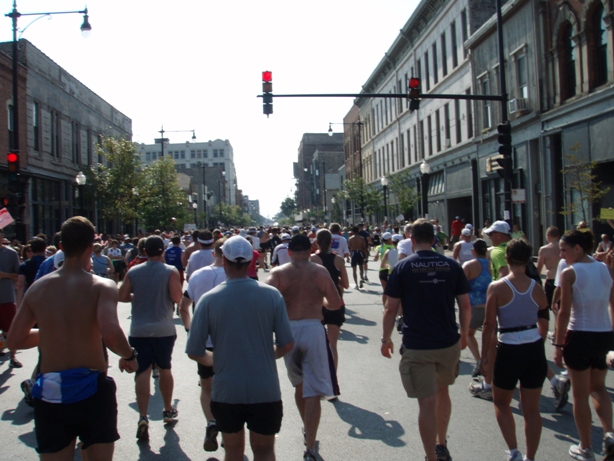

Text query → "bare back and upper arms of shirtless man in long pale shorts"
[266,260,341,320]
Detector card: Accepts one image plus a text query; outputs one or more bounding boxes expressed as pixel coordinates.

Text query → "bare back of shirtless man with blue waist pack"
[23,268,118,373]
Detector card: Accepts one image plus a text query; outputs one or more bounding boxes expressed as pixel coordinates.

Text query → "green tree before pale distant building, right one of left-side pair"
[139,156,193,230]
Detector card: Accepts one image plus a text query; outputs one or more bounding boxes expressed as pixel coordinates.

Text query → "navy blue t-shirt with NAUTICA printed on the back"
[386,250,470,349]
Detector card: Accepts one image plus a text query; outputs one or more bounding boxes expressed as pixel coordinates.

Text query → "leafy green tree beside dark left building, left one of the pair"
[85,137,142,222]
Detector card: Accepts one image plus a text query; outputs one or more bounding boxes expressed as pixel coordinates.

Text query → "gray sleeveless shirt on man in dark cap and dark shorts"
[126,261,177,338]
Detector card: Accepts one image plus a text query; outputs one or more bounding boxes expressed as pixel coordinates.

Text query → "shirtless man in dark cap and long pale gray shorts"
[266,234,342,461]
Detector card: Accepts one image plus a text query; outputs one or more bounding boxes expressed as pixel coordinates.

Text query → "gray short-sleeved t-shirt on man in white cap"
[186,278,294,404]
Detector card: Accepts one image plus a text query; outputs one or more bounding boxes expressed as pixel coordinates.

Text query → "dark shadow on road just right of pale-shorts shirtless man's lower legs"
[333,400,405,447]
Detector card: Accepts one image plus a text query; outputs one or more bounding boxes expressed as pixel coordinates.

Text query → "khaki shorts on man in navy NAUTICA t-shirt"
[399,341,461,399]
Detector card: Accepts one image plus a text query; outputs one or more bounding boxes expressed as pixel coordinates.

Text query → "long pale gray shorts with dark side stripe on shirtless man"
[284,319,339,398]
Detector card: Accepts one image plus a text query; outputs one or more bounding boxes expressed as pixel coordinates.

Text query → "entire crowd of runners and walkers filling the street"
[0,217,614,461]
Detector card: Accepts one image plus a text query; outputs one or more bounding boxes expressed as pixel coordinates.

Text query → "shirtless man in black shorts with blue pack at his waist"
[7,216,137,460]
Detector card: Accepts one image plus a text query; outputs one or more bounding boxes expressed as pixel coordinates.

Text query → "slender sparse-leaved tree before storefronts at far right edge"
[560,143,610,222]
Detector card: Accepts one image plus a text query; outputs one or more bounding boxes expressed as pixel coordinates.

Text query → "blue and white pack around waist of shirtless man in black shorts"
[32,368,100,403]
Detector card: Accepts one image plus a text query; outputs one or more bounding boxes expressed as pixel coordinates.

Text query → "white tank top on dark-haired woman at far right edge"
[567,261,612,332]
